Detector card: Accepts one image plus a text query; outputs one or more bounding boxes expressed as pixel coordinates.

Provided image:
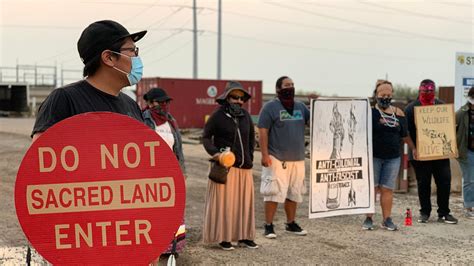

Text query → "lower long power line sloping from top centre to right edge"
[265,2,472,45]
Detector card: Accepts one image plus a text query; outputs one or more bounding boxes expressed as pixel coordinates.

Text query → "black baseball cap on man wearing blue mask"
[77,20,147,64]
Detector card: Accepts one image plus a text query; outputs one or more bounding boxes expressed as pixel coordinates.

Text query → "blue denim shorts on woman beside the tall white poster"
[373,157,400,190]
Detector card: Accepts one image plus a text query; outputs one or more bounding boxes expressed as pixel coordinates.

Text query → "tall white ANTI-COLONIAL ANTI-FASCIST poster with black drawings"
[309,98,375,218]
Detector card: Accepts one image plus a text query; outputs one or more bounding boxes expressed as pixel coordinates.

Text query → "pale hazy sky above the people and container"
[0,0,474,96]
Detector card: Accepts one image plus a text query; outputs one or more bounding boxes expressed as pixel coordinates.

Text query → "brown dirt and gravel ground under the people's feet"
[0,118,474,265]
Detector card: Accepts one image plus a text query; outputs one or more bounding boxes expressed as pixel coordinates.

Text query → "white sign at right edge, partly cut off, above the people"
[454,53,474,111]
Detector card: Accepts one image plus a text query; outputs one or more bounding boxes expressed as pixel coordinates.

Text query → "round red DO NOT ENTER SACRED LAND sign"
[15,112,185,265]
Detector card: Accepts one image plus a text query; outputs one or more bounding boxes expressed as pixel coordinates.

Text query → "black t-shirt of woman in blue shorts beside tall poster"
[372,108,408,159]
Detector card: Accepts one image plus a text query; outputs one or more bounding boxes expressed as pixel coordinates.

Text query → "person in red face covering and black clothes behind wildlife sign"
[405,79,458,224]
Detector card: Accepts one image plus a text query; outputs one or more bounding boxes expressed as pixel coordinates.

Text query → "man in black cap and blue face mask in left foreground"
[31,20,147,141]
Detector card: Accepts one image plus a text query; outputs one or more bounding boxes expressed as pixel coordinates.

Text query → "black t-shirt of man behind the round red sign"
[31,80,143,136]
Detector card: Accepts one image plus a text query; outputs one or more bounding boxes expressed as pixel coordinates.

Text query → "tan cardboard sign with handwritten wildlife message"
[415,104,458,161]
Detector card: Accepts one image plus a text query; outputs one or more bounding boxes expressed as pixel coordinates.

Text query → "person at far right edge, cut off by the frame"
[456,87,474,219]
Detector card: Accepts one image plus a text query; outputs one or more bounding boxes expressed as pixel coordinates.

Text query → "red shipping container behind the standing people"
[137,77,262,128]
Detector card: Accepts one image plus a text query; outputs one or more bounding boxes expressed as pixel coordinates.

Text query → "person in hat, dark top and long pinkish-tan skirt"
[203,81,258,250]
